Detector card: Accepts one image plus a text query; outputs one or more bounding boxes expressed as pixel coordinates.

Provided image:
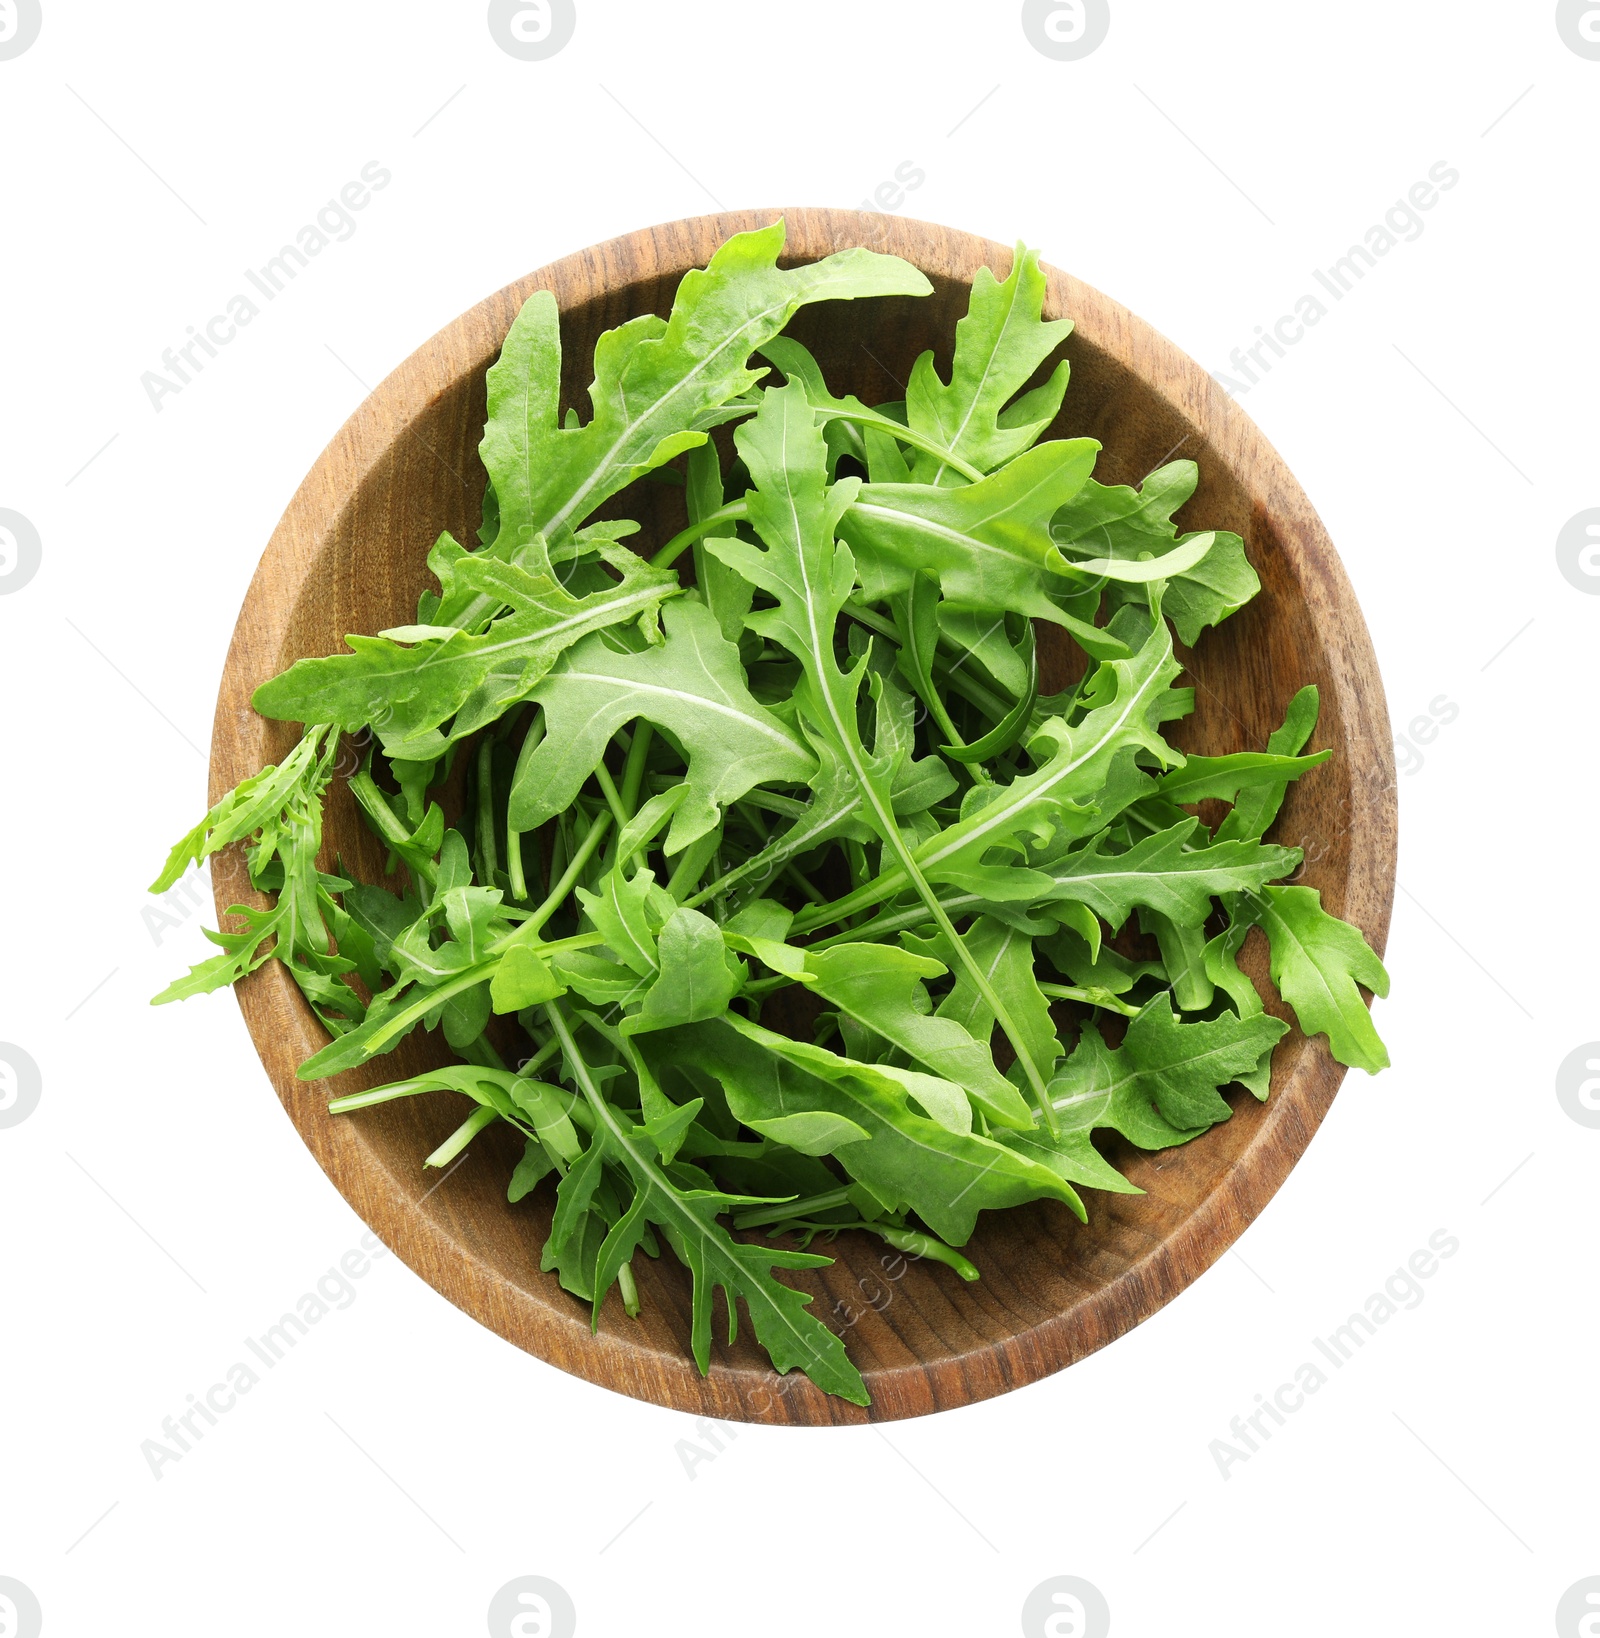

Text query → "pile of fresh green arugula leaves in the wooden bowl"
[154,223,1387,1404]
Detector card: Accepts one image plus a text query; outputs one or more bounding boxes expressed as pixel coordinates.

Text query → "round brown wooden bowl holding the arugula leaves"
[211,210,1395,1425]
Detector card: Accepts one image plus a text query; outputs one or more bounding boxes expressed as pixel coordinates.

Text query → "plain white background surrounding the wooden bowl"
[0,0,1600,1638]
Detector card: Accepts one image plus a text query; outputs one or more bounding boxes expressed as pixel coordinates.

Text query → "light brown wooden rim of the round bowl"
[210,208,1397,1425]
